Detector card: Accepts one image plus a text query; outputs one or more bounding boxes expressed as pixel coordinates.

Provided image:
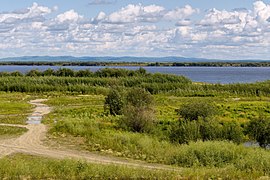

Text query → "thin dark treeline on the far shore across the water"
[0,61,270,67]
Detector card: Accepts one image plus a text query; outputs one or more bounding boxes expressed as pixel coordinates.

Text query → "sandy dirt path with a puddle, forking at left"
[0,99,179,171]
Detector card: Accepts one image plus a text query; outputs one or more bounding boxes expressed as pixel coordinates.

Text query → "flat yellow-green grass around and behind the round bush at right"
[155,95,270,122]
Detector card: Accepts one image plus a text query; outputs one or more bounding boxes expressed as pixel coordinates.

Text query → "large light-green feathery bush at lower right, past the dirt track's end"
[171,141,270,172]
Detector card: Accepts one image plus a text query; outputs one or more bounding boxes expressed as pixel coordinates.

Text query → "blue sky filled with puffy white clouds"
[0,0,270,59]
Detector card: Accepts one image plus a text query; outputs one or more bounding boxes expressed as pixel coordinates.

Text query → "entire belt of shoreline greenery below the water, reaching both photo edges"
[0,68,270,97]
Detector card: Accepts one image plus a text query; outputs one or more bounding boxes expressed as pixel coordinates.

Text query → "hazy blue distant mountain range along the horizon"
[0,56,267,62]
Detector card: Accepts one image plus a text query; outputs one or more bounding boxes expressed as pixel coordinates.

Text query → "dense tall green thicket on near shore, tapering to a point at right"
[0,68,192,94]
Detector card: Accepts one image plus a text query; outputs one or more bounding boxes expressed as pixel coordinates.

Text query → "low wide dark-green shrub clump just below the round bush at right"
[170,118,244,144]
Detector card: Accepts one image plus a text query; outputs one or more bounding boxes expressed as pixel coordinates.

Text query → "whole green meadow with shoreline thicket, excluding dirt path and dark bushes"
[0,69,270,179]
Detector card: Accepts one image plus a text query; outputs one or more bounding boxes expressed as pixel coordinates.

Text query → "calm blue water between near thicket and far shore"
[0,66,270,84]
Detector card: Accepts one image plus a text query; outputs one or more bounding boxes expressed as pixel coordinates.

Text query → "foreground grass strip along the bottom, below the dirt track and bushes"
[0,154,266,179]
